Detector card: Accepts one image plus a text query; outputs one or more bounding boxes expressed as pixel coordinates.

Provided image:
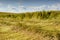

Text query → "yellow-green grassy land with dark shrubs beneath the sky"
[0,11,60,40]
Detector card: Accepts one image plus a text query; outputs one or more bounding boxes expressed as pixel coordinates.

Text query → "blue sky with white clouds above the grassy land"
[0,0,60,12]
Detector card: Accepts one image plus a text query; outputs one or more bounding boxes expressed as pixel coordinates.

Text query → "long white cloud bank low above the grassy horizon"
[0,3,60,12]
